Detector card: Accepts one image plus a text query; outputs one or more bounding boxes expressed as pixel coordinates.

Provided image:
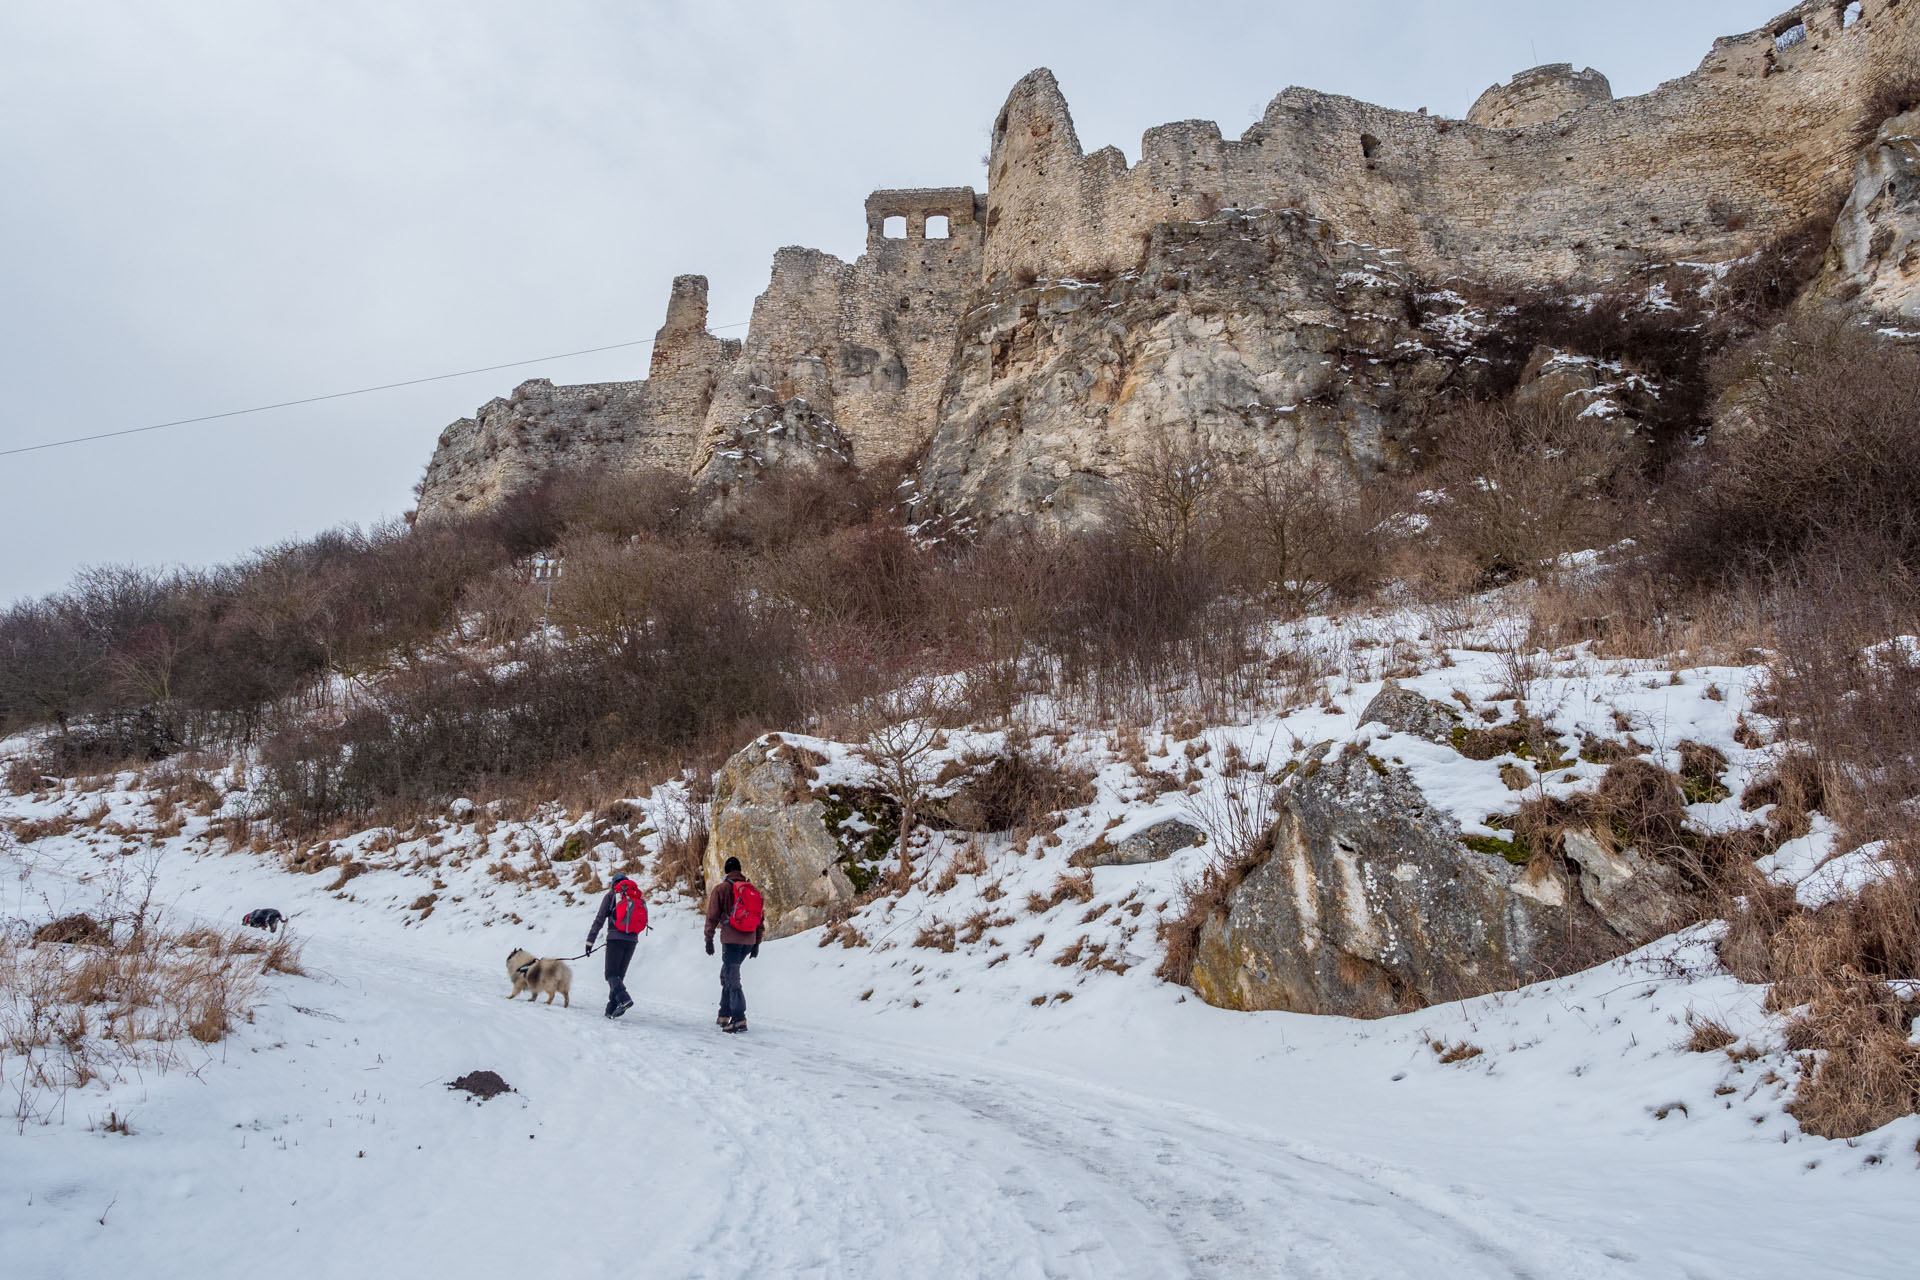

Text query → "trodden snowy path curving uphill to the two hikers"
[0,932,1643,1278]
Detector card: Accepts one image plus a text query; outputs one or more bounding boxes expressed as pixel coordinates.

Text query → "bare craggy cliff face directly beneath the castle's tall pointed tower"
[920,209,1457,532]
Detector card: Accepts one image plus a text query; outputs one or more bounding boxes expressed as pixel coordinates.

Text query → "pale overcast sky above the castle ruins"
[0,0,1786,601]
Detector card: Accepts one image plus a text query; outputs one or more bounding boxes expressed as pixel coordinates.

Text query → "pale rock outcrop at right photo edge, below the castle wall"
[1812,109,1920,320]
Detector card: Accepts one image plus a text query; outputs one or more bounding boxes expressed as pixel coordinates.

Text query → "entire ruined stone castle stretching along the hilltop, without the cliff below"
[419,0,1920,518]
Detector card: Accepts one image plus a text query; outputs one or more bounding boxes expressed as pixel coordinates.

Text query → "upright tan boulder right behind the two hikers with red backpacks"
[705,733,854,938]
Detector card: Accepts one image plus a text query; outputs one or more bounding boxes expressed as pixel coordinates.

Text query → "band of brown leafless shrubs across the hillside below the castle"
[0,307,1920,1136]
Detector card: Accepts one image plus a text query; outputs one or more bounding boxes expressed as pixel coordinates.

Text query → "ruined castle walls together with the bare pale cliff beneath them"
[419,0,1920,528]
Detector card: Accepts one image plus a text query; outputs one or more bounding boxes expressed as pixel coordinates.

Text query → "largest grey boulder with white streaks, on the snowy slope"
[1192,747,1630,1017]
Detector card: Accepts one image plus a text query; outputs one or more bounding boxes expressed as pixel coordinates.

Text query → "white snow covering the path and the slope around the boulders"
[0,610,1920,1280]
